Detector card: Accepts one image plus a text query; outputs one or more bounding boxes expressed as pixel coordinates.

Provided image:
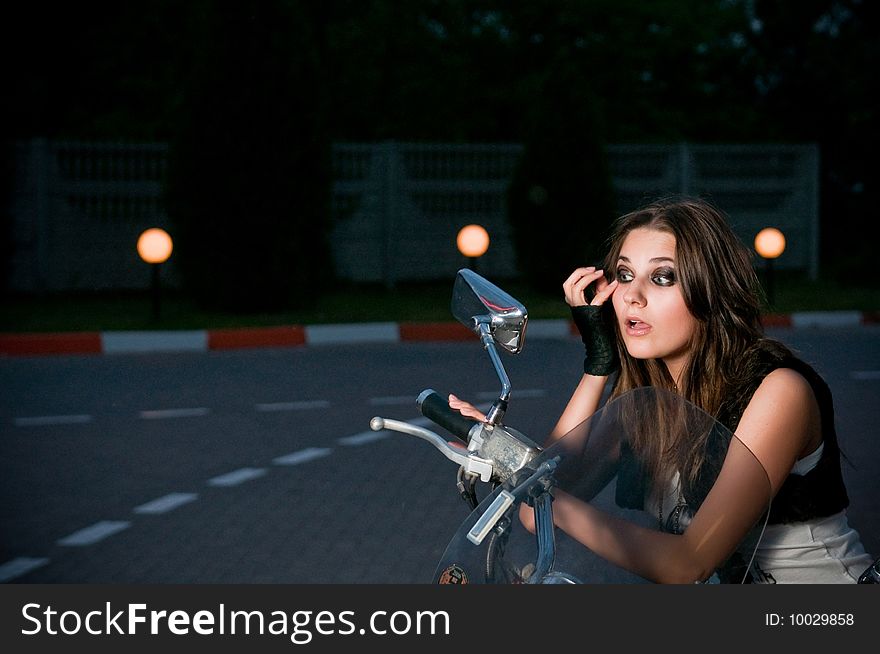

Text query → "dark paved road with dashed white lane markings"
[0,326,880,583]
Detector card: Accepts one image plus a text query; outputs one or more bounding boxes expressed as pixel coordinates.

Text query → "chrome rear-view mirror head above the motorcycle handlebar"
[452,268,528,354]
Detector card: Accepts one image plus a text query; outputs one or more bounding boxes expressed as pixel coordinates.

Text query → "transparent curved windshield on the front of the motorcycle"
[434,387,771,583]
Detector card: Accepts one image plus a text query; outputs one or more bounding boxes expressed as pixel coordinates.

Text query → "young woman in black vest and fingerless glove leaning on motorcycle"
[449,199,871,583]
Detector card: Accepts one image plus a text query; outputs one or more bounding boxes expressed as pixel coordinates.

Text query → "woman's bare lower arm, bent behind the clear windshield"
[520,369,819,583]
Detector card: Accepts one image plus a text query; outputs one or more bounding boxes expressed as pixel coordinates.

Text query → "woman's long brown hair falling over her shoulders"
[604,198,763,490]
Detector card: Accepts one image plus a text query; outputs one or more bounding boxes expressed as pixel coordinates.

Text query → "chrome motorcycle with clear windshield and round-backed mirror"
[370,269,872,584]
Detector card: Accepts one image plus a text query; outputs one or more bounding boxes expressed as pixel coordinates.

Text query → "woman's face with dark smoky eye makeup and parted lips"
[612,227,697,381]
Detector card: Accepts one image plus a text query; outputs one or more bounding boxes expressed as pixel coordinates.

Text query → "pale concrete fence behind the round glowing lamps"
[10,139,819,292]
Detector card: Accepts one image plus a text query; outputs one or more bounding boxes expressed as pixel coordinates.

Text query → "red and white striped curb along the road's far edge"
[0,311,880,356]
